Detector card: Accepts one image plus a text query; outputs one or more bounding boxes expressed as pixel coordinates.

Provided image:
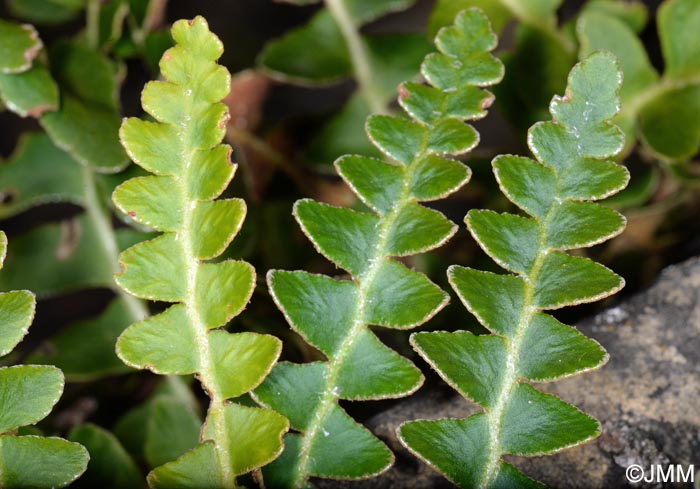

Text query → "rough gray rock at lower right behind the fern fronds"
[317,258,700,489]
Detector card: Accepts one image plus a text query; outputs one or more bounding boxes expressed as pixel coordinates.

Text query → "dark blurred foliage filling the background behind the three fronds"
[0,0,700,487]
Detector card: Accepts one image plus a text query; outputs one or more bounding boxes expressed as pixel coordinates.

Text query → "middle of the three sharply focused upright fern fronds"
[254,9,503,487]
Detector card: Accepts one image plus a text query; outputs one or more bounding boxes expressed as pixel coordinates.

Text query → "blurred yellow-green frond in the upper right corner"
[577,0,700,161]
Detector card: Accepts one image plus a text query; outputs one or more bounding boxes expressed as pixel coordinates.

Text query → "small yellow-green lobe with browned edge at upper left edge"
[0,20,43,73]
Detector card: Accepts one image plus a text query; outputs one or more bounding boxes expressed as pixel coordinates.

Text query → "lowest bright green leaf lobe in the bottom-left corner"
[0,435,90,489]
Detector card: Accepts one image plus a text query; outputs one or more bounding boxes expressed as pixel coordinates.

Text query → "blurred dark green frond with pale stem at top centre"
[258,0,430,165]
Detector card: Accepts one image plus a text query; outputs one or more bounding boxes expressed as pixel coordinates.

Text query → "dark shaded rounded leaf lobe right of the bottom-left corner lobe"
[68,423,145,489]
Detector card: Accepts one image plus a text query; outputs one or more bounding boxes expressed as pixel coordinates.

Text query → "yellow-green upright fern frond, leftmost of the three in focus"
[113,17,288,488]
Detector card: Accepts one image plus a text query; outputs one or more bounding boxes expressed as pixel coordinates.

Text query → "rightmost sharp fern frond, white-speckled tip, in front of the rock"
[398,52,628,488]
